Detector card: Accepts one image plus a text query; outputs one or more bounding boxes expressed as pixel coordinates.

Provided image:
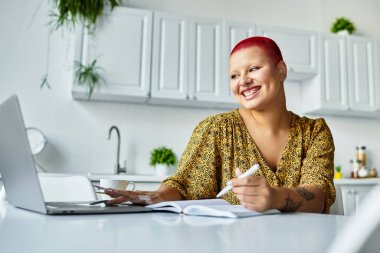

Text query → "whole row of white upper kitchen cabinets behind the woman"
[72,7,380,117]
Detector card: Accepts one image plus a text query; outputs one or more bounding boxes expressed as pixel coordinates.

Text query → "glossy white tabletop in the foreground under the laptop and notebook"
[0,204,348,253]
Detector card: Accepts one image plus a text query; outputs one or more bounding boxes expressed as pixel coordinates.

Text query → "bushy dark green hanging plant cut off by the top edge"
[51,0,120,31]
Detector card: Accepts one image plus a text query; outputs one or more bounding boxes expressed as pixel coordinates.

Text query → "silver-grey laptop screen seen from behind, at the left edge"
[0,95,46,213]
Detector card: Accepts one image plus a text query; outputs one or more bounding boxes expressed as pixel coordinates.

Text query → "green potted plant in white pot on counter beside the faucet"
[150,147,177,176]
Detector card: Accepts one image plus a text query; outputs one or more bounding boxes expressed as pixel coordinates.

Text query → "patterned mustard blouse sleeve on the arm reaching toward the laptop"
[163,118,220,199]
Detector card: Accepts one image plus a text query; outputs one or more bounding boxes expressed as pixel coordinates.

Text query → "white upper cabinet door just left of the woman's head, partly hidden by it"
[221,21,256,107]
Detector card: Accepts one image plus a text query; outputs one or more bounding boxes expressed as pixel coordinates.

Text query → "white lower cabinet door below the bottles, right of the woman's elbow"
[341,185,374,215]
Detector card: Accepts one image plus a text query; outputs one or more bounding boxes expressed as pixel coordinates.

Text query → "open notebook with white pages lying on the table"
[147,199,280,218]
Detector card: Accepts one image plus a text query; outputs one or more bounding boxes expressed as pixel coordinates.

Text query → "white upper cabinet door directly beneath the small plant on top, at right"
[320,34,348,110]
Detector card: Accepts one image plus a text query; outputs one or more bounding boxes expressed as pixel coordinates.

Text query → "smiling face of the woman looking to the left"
[230,47,286,110]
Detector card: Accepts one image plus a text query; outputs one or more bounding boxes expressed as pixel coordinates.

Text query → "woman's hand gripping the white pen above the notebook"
[231,169,276,212]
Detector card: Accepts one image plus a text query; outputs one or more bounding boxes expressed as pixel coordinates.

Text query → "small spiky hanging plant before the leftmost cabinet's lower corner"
[74,60,104,99]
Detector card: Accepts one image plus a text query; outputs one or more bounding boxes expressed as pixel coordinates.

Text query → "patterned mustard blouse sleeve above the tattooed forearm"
[299,119,335,213]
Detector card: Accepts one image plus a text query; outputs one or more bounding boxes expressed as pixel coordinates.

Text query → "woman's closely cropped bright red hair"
[230,36,283,64]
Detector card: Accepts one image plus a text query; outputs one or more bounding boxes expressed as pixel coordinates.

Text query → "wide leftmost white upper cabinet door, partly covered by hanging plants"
[73,7,152,102]
